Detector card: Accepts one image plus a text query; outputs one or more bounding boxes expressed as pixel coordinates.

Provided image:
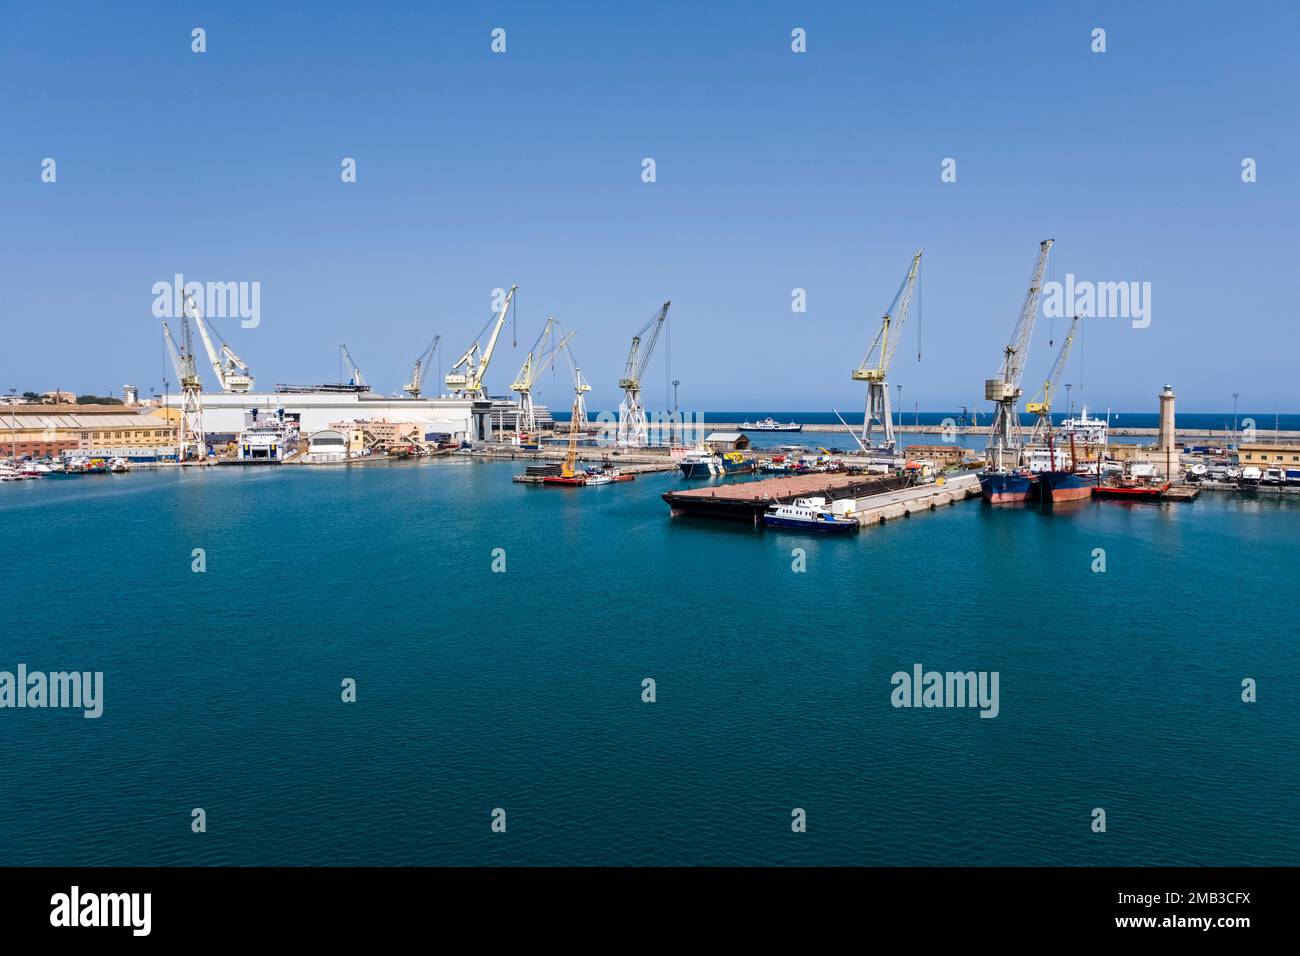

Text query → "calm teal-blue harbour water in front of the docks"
[0,460,1300,865]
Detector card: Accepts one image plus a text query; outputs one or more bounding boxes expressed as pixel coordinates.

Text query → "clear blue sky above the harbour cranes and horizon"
[0,3,1300,414]
